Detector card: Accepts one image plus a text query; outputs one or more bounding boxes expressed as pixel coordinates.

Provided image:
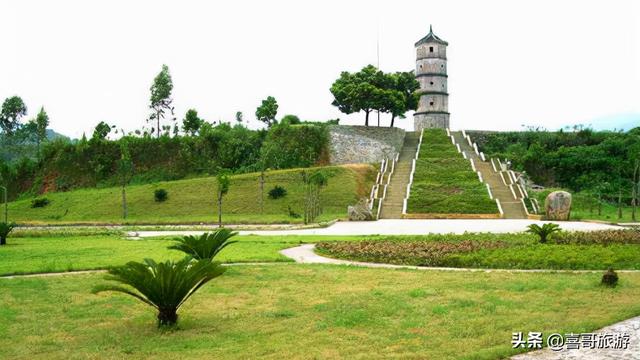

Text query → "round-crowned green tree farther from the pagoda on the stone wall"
[330,65,388,126]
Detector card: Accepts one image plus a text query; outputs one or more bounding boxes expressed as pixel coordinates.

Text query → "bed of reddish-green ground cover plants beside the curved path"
[317,230,640,270]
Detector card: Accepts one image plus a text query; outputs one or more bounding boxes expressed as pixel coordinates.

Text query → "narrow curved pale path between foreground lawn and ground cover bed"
[280,244,640,273]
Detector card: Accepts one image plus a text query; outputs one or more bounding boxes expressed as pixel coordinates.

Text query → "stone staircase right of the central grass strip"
[451,131,527,219]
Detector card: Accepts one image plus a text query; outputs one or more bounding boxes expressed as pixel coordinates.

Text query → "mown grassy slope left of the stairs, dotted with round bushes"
[9,165,375,224]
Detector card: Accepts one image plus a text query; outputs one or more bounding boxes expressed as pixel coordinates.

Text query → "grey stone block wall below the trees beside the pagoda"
[329,125,405,164]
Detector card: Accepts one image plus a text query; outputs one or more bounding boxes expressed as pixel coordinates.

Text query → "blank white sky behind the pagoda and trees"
[0,0,640,137]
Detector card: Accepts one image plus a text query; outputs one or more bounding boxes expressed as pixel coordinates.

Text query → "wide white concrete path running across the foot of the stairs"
[129,219,621,237]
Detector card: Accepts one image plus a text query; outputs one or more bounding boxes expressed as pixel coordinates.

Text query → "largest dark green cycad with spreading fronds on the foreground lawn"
[93,257,226,326]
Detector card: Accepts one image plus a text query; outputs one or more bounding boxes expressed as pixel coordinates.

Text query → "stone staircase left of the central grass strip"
[380,132,420,219]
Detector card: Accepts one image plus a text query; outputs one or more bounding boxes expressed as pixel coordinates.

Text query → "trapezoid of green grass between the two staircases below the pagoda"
[407,129,498,214]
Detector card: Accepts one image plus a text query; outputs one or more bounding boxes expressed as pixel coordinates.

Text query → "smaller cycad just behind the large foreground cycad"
[169,228,238,261]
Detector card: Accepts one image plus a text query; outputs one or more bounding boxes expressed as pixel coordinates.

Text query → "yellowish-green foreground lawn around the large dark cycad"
[0,265,640,360]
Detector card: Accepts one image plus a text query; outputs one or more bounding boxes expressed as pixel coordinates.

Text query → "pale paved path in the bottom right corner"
[511,316,640,360]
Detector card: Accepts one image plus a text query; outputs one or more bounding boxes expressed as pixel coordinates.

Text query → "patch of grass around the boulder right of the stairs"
[529,188,640,222]
